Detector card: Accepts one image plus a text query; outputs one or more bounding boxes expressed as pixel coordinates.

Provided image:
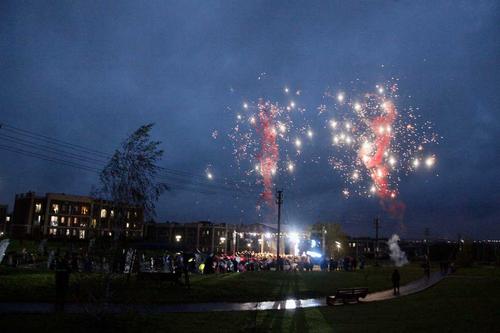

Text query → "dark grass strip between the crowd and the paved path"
[0,265,423,303]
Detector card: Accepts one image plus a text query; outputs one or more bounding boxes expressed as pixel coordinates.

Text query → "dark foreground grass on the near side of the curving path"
[0,268,500,333]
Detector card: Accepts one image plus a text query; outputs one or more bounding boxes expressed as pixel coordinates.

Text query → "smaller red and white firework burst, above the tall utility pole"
[229,87,314,207]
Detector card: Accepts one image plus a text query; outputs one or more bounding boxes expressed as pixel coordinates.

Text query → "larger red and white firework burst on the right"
[320,84,437,211]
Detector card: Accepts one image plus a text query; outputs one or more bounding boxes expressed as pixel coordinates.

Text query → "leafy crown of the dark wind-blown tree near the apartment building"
[94,124,168,222]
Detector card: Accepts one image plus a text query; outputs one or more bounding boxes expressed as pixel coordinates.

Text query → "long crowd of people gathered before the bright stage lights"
[7,245,365,274]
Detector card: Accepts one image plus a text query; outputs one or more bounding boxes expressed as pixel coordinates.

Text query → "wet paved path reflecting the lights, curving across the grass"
[0,272,443,313]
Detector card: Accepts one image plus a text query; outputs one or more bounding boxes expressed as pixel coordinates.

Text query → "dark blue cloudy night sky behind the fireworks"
[0,0,500,239]
